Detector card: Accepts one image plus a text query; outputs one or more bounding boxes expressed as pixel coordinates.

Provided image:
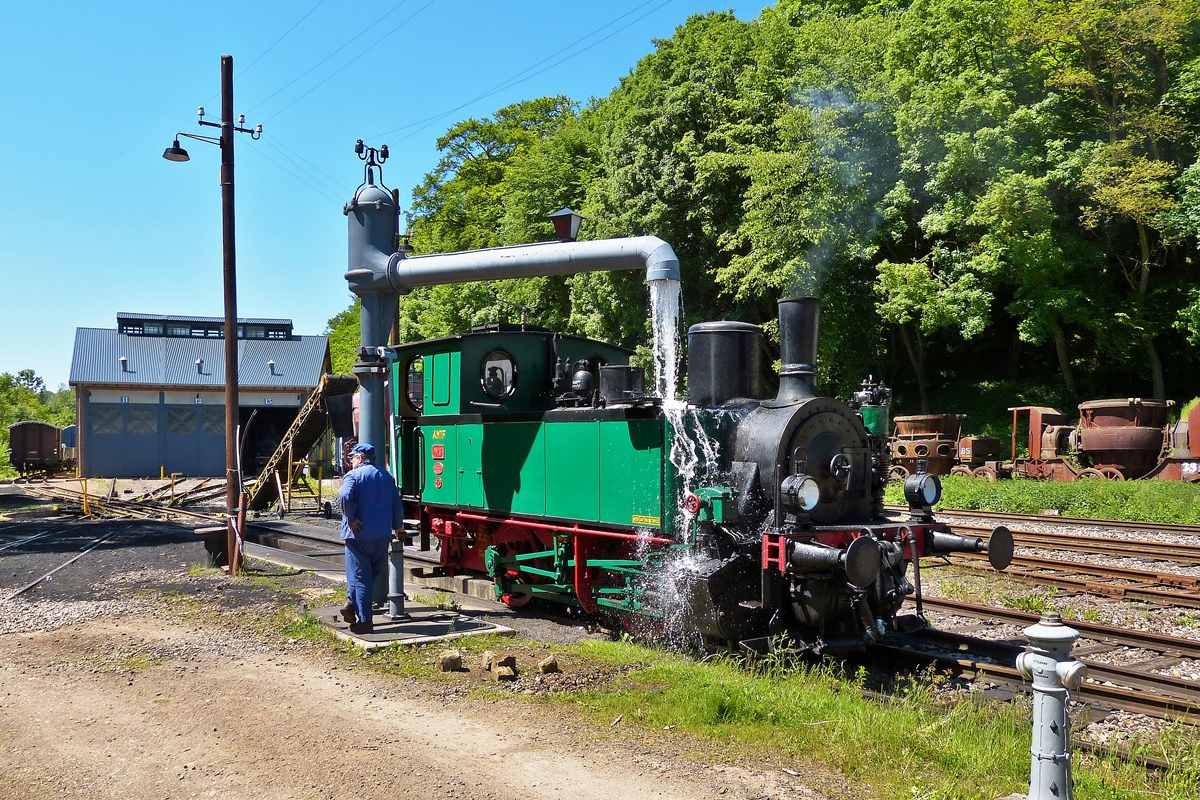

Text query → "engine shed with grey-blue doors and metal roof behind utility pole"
[70,312,330,477]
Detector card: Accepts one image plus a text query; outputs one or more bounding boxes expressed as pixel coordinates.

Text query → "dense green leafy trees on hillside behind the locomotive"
[332,0,1200,431]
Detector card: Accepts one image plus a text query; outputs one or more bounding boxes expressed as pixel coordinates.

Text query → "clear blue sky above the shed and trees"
[0,0,748,387]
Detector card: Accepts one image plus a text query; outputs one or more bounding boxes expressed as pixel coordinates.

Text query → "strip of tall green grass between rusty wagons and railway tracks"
[884,475,1200,525]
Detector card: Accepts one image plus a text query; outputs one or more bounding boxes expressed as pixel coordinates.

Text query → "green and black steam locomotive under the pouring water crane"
[390,297,1013,650]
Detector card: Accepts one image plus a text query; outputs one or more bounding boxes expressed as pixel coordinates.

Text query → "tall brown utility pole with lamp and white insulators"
[162,55,263,576]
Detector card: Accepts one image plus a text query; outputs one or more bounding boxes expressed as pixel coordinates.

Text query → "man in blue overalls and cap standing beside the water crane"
[338,443,404,633]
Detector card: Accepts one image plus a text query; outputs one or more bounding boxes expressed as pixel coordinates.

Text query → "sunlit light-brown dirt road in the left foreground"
[0,515,848,800]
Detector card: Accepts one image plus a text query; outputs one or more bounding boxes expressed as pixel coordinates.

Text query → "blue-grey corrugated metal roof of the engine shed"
[70,326,329,389]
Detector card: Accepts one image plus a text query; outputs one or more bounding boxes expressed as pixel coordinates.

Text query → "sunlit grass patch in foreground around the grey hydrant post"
[549,642,1200,800]
